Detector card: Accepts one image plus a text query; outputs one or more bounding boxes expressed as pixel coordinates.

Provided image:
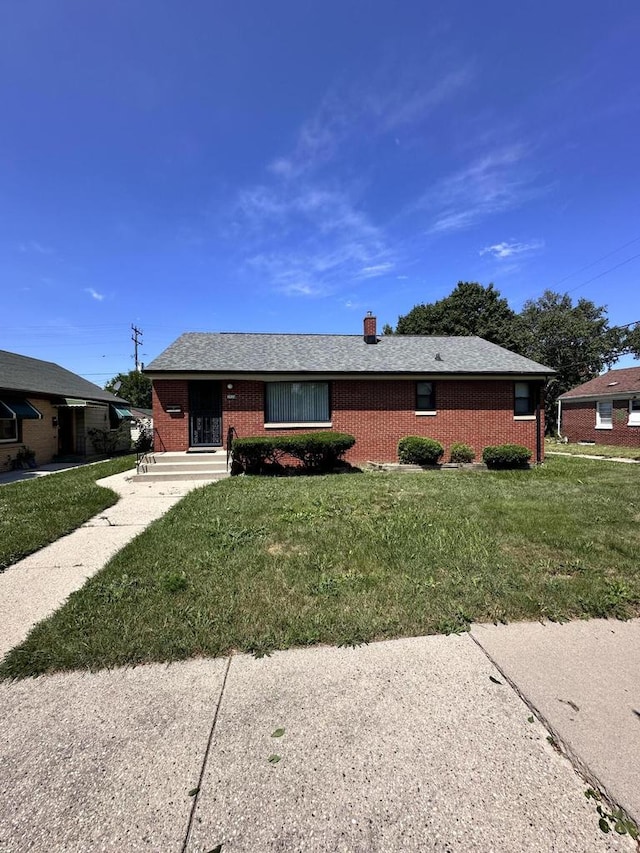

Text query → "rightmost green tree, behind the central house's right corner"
[520,290,625,432]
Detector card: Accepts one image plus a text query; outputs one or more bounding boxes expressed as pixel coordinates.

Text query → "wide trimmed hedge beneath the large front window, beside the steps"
[232,431,356,474]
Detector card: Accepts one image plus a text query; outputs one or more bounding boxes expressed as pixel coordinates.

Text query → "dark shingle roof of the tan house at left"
[0,350,125,403]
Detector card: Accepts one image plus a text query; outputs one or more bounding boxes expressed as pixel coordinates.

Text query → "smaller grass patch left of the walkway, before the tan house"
[0,456,135,572]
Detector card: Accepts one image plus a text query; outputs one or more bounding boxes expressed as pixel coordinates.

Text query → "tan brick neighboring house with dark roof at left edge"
[0,350,131,471]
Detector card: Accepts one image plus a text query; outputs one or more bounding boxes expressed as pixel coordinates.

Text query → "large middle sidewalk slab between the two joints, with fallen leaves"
[187,635,635,853]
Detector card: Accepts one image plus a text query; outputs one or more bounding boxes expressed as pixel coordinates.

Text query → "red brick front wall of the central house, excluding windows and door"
[153,379,544,462]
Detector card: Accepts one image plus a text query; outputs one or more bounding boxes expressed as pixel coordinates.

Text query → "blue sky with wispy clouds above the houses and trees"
[0,0,640,385]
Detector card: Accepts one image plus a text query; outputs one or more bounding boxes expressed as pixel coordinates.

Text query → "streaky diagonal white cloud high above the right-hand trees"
[417,144,545,234]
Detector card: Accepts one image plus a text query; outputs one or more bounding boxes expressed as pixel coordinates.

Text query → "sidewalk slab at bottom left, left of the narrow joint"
[0,659,227,853]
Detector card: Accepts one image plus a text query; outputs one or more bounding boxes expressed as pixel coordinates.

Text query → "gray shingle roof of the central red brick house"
[146,332,554,376]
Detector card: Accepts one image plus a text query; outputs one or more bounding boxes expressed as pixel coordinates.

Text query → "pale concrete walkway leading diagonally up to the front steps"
[0,471,216,656]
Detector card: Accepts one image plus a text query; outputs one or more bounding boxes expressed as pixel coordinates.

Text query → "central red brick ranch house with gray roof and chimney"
[145,315,553,462]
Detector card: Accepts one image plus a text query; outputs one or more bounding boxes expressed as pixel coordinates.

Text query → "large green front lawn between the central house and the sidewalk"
[0,457,640,678]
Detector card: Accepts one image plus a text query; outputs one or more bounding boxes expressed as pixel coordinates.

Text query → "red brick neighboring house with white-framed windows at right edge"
[558,365,640,447]
